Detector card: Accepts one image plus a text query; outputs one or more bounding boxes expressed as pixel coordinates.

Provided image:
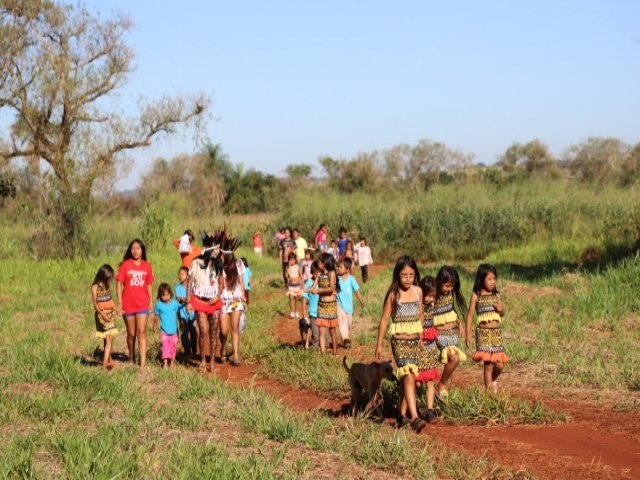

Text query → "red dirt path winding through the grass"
[205,268,640,480]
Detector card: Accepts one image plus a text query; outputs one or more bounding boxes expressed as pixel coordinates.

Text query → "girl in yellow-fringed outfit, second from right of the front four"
[433,265,467,401]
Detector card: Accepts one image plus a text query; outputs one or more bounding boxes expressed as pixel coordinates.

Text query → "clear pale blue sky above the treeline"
[81,0,640,188]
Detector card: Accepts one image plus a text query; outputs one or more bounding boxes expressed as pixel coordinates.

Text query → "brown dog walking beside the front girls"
[342,357,396,416]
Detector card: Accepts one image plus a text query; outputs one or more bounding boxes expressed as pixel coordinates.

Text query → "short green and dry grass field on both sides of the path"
[0,182,640,479]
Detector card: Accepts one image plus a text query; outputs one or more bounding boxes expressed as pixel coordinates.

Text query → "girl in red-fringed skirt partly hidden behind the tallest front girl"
[416,275,440,423]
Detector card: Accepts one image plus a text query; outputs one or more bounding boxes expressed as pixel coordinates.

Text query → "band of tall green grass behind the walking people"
[271,180,640,261]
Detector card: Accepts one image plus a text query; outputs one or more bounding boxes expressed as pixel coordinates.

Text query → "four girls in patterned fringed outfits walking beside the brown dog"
[375,256,509,432]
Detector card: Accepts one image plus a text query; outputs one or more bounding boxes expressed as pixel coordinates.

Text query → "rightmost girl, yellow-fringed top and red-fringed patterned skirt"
[466,263,509,393]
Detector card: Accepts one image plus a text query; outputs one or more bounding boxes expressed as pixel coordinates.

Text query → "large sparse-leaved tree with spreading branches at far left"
[0,0,209,254]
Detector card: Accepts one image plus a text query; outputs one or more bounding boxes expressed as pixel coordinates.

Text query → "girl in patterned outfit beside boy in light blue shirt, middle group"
[311,253,340,356]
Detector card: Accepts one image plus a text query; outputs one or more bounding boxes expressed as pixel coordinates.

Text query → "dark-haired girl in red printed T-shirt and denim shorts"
[115,238,154,367]
